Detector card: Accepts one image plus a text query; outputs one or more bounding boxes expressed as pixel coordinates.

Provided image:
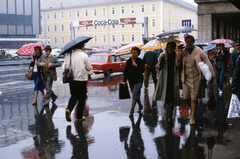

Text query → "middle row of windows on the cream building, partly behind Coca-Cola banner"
[41,19,156,32]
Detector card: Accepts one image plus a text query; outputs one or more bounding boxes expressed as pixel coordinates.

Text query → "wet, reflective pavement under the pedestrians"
[0,65,240,159]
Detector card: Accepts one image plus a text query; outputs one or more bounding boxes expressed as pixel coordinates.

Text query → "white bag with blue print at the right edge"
[227,94,240,118]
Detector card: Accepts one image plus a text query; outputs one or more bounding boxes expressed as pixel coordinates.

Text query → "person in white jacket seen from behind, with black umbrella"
[60,36,92,122]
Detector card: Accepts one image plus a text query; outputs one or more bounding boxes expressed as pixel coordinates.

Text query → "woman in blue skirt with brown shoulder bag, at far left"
[30,46,46,105]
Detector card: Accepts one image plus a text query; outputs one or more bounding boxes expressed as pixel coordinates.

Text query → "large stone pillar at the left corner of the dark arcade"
[198,14,212,43]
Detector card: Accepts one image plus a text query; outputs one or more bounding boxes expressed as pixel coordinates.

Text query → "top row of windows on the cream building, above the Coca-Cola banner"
[41,4,156,20]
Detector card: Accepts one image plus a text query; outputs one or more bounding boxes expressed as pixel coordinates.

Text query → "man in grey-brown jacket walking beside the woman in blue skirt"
[37,45,62,106]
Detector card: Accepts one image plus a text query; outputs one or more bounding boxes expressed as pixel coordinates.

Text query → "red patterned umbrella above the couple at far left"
[17,43,44,55]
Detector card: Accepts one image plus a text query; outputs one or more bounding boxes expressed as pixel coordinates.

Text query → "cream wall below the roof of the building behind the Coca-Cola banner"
[38,1,198,47]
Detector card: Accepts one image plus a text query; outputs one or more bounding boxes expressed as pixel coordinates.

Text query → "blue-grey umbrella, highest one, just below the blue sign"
[157,27,197,38]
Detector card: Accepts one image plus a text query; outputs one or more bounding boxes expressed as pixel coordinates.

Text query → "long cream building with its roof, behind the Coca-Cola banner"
[38,0,198,47]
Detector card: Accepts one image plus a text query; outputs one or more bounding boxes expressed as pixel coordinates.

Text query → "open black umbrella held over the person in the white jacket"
[59,36,92,56]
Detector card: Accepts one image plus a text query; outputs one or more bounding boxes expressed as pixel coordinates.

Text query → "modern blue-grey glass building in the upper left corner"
[0,0,41,48]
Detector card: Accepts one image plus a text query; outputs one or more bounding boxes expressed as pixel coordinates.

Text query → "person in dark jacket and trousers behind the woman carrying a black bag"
[143,51,158,91]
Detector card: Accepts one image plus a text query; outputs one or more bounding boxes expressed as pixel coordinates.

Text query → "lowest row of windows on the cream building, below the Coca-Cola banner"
[48,34,156,44]
